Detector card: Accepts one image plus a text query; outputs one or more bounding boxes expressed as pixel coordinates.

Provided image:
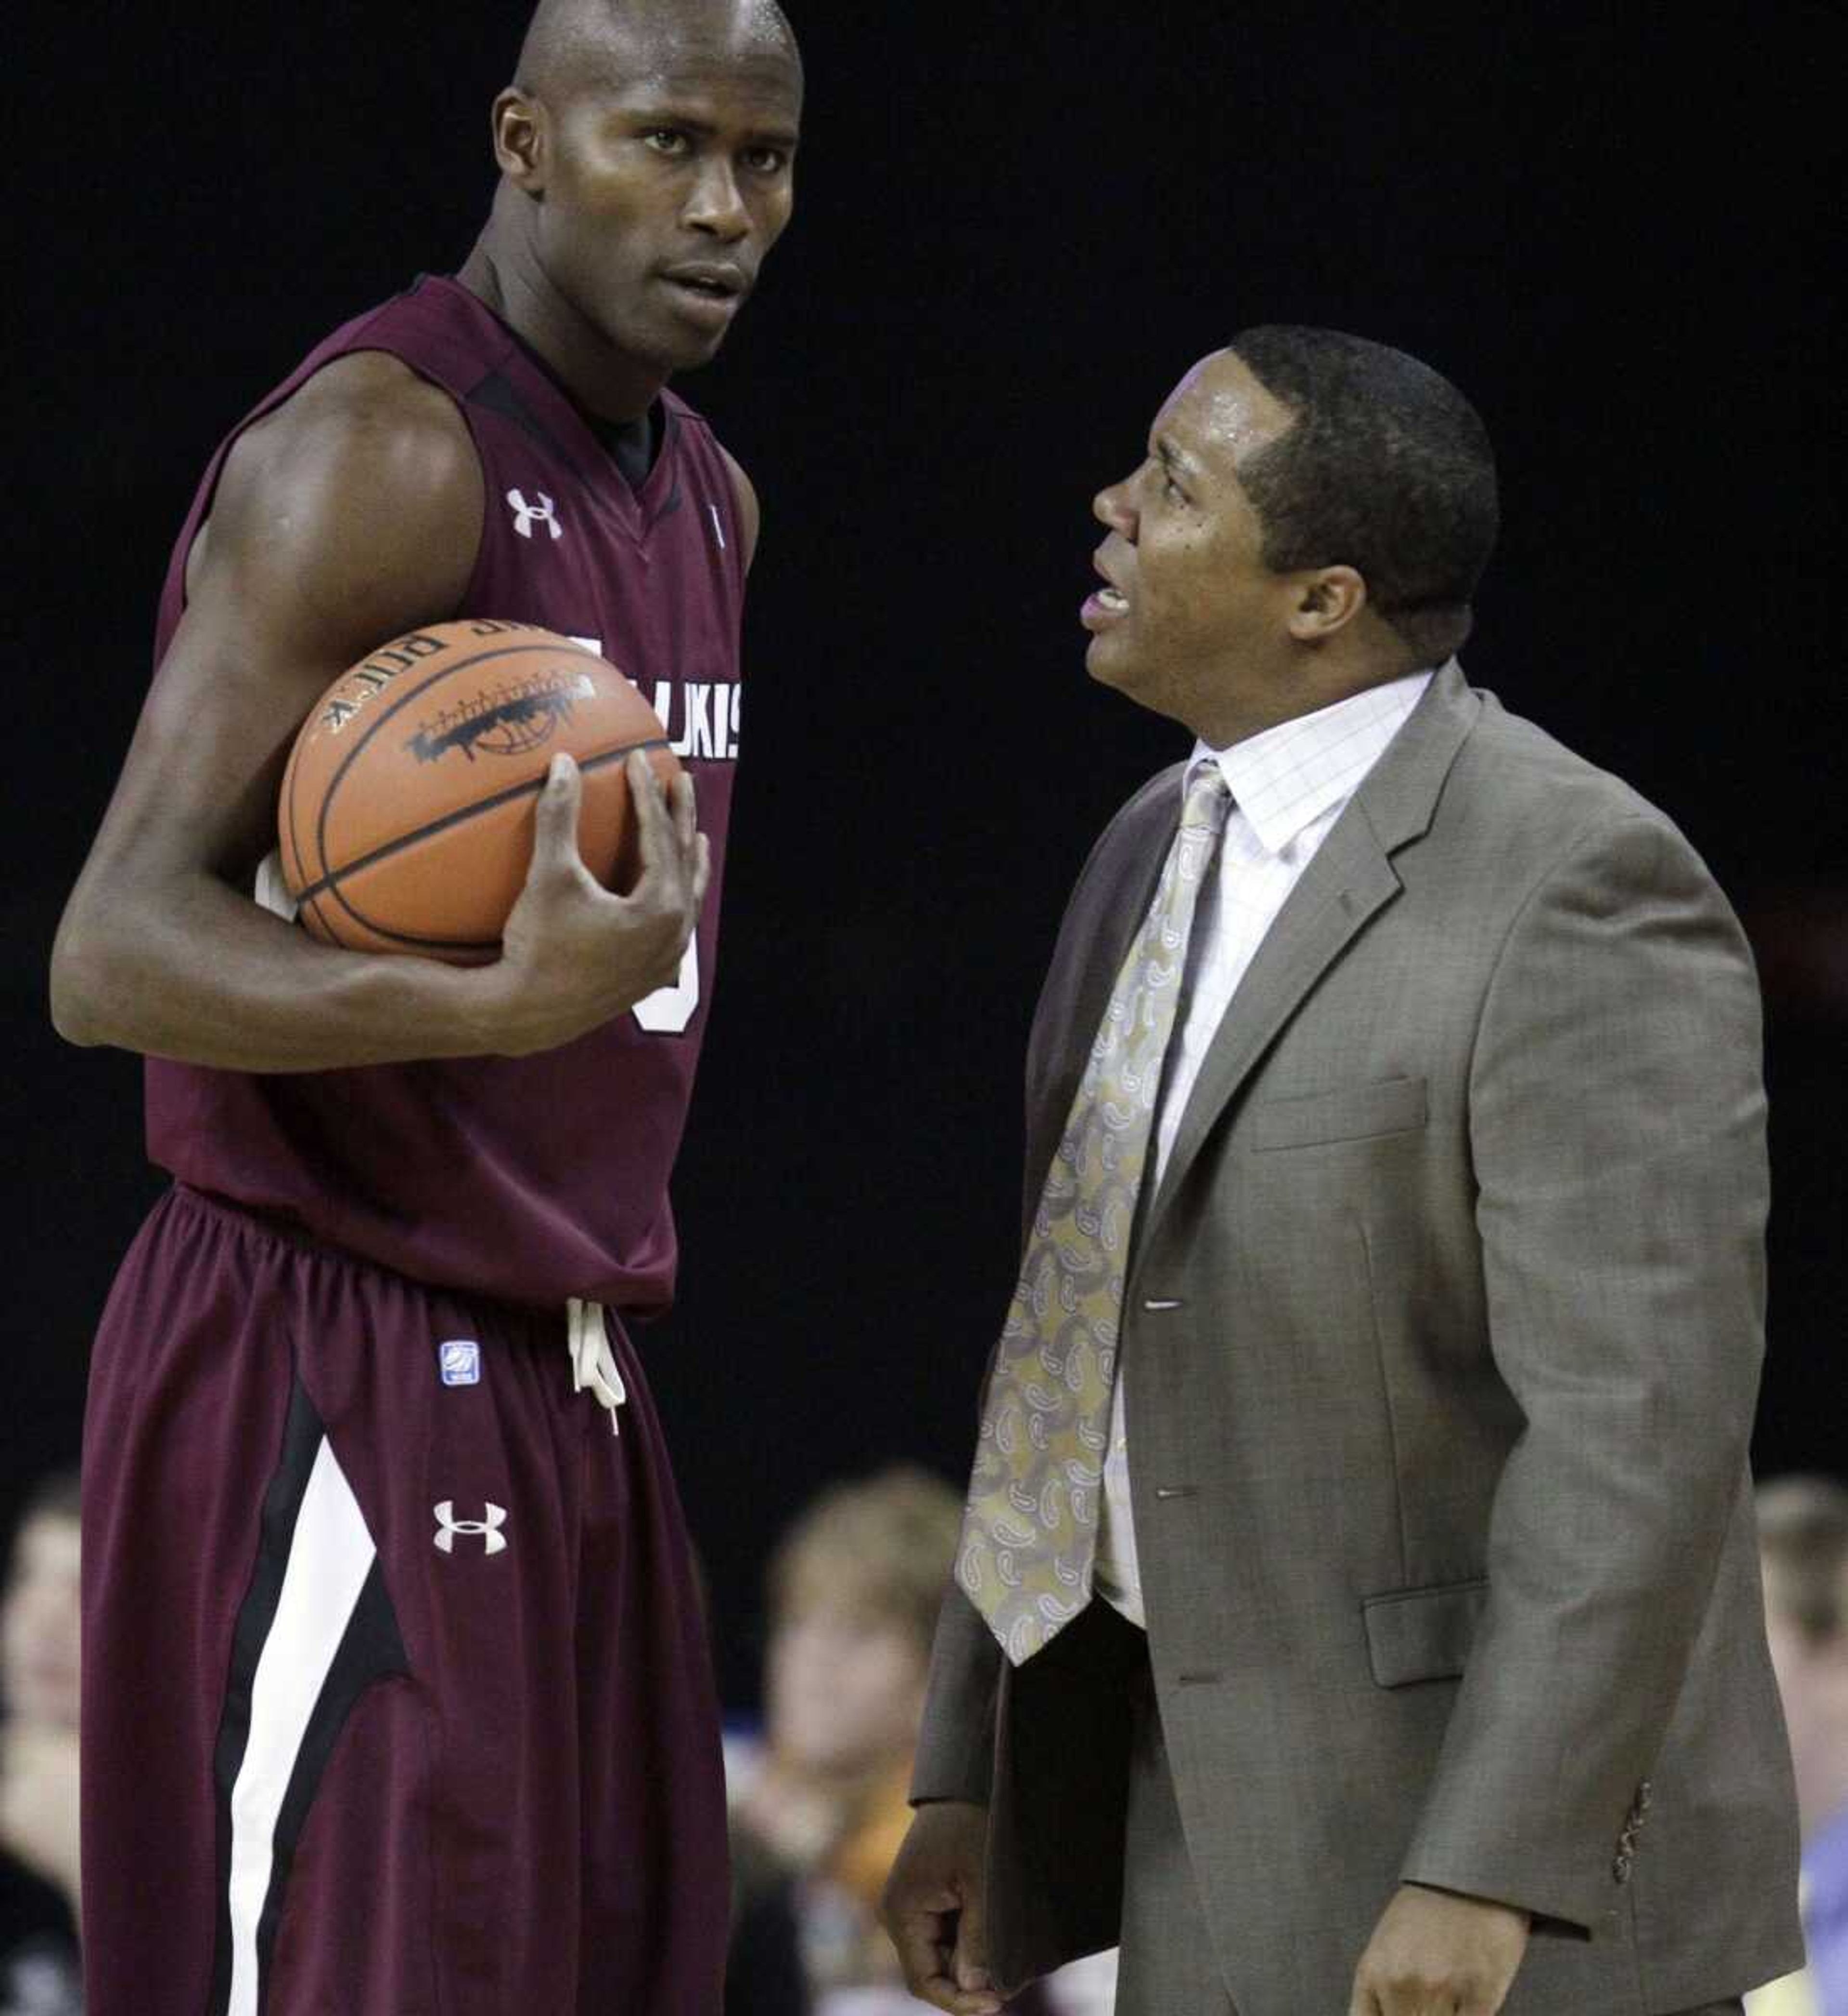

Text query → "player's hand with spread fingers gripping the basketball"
[488,750,711,1056]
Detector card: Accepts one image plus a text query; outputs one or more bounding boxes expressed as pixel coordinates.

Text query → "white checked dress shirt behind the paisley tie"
[1094,671,1433,1625]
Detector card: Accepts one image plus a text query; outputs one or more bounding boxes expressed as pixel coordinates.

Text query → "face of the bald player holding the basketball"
[502,4,802,371]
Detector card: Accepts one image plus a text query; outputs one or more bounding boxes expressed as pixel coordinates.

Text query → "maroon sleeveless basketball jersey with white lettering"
[147,278,744,1312]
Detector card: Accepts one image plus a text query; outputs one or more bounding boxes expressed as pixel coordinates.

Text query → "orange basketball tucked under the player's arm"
[276,621,679,966]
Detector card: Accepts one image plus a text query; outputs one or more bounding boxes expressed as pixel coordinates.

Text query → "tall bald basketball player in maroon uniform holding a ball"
[52,0,802,2016]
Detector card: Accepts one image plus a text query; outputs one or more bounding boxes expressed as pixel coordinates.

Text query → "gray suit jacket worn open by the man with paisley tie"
[913,665,1802,2016]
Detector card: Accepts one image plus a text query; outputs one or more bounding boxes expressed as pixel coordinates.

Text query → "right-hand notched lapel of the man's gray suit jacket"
[1139,661,1481,1248]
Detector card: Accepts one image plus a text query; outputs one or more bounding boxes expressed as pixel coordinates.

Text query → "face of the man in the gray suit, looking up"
[1080,351,1302,748]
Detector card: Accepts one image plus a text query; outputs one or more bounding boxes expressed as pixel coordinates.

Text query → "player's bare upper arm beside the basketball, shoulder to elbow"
[73,369,482,893]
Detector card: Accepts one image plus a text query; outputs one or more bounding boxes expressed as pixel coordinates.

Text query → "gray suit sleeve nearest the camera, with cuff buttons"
[1403,817,1767,1931]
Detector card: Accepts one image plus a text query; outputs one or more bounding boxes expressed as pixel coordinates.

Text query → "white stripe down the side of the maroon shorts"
[228,1438,377,2016]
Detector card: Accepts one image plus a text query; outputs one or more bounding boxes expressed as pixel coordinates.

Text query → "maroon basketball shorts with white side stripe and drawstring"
[83,1190,728,2016]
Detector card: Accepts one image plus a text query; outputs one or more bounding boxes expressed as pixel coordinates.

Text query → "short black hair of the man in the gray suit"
[1232,322,1500,665]
